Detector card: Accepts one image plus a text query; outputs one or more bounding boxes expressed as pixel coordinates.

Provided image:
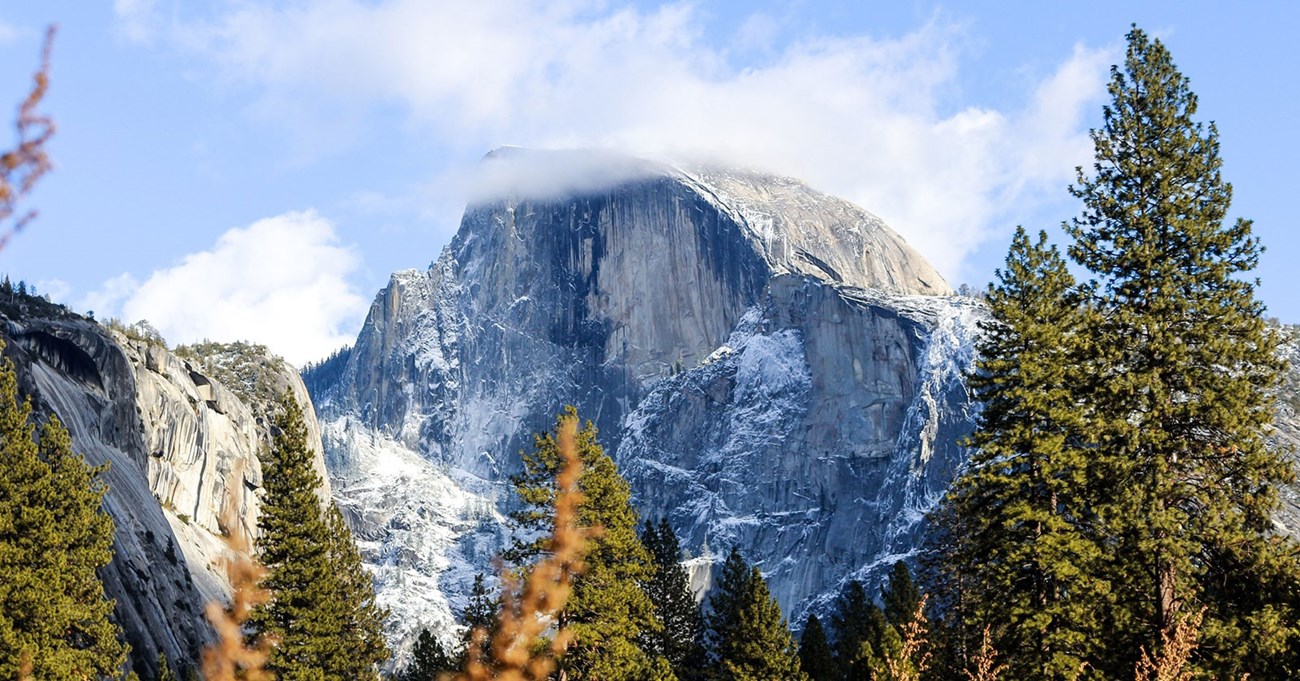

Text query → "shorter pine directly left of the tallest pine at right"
[931,229,1106,678]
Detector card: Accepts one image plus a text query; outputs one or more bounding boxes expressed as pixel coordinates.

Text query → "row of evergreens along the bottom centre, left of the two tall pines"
[398,407,924,681]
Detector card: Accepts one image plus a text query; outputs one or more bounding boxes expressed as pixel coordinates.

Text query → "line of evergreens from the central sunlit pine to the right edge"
[395,22,1300,681]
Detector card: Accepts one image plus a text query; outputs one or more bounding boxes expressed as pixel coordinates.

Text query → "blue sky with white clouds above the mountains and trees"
[0,0,1300,363]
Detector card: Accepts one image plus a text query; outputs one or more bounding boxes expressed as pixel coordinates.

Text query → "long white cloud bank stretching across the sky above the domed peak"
[149,0,1106,276]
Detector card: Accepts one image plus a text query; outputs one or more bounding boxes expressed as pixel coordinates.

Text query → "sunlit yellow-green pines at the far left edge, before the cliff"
[0,345,126,678]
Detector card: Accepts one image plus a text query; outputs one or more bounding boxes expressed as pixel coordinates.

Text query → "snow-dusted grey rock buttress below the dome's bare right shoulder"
[618,277,984,620]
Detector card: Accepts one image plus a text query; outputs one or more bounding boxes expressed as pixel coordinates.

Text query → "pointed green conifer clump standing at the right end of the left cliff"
[250,394,387,681]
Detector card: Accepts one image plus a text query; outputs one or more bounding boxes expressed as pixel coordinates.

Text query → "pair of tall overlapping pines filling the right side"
[933,27,1300,678]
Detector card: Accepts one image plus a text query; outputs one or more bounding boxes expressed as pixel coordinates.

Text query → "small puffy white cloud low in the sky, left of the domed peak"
[83,211,367,365]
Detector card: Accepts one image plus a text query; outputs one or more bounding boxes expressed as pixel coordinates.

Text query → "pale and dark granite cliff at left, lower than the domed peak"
[0,305,329,678]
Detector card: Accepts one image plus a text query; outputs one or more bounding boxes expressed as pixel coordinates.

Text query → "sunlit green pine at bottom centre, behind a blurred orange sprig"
[506,407,662,681]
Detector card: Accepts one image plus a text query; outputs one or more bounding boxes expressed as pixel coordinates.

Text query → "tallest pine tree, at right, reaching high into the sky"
[1067,27,1300,678]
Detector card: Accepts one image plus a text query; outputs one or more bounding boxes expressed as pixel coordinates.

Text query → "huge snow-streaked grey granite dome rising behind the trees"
[306,152,980,655]
